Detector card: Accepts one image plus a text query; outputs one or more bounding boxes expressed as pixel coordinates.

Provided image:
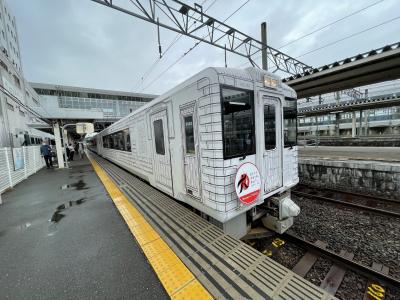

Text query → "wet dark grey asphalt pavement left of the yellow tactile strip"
[0,159,168,299]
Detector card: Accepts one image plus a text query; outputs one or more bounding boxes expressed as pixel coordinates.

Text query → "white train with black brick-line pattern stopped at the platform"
[94,68,300,238]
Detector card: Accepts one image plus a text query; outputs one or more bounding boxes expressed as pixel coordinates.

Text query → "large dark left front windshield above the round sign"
[221,88,256,159]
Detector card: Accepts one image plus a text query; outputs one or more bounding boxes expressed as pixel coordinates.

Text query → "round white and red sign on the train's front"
[235,163,261,205]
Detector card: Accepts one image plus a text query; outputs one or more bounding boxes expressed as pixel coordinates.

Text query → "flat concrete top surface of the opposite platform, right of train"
[299,146,400,163]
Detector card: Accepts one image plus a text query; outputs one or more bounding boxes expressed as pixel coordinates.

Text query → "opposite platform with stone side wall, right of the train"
[299,146,400,201]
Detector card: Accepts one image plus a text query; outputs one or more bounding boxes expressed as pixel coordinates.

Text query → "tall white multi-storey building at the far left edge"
[0,0,52,147]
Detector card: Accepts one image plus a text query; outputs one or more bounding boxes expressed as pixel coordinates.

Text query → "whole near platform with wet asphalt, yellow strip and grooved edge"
[0,154,334,299]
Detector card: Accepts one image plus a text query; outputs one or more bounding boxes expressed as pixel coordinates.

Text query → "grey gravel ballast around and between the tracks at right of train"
[288,196,400,299]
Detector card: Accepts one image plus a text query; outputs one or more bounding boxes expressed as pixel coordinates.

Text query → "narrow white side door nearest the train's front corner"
[180,103,200,198]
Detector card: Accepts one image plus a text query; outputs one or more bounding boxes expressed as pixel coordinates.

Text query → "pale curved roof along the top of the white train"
[101,67,296,132]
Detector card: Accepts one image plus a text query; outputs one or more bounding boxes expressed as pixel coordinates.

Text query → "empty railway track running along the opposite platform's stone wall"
[292,186,400,218]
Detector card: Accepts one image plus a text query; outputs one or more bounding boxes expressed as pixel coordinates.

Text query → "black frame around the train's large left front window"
[220,84,257,160]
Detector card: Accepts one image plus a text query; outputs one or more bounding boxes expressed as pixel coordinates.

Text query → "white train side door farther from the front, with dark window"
[150,110,173,194]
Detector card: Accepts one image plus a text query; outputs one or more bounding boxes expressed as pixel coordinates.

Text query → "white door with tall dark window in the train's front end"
[263,95,283,194]
